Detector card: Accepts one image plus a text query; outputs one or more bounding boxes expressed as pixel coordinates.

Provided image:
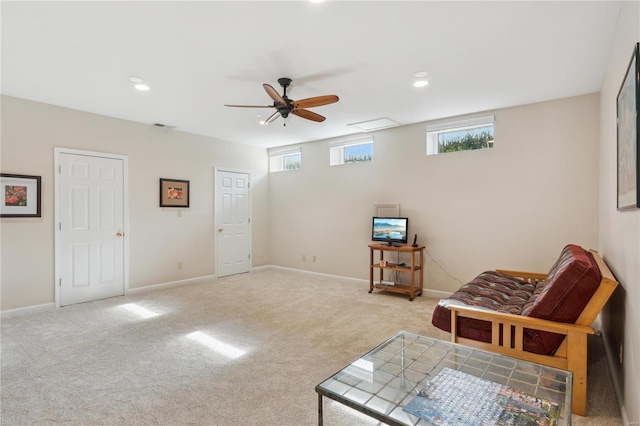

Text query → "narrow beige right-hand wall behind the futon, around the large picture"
[599,1,640,424]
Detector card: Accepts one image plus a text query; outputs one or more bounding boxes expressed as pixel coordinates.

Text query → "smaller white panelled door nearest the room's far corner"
[216,170,251,277]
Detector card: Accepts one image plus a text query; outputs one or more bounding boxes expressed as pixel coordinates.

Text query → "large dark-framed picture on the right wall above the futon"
[616,43,640,211]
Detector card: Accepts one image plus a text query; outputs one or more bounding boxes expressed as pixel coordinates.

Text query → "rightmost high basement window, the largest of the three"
[427,115,494,155]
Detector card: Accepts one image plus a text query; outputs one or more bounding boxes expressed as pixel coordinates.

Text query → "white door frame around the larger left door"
[53,147,129,308]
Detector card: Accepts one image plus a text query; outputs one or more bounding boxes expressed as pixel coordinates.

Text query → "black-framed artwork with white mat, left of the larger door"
[0,173,42,217]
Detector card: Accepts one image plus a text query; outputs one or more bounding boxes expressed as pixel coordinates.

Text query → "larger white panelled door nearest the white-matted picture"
[56,153,124,306]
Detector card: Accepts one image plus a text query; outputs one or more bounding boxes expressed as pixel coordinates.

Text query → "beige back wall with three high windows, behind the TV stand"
[269,94,599,292]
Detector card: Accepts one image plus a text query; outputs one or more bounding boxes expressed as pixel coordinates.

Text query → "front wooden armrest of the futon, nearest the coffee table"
[448,305,594,335]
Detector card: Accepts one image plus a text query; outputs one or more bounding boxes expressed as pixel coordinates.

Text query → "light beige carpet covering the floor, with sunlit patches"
[0,269,622,426]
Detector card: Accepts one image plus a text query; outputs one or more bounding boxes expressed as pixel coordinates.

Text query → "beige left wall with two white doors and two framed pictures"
[0,96,268,310]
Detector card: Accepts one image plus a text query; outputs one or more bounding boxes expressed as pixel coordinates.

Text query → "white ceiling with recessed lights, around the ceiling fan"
[1,0,620,147]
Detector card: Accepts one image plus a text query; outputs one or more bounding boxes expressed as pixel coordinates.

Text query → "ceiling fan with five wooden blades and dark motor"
[225,77,339,126]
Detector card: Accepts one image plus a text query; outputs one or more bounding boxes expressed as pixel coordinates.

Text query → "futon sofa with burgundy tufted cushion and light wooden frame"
[432,244,618,416]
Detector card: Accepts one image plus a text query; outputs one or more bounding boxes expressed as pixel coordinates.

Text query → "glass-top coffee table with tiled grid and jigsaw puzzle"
[316,331,572,426]
